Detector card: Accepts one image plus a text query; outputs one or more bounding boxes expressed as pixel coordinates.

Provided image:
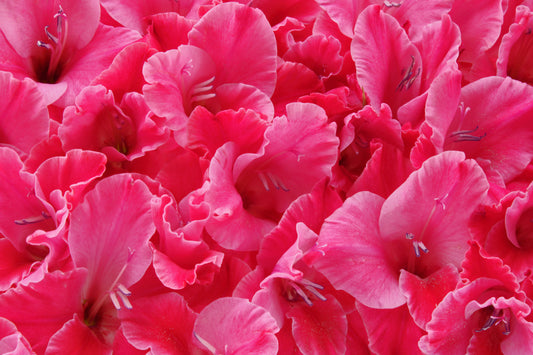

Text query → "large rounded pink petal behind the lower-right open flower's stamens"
[379,151,488,277]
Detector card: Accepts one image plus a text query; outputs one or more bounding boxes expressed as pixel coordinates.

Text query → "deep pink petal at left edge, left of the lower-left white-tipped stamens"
[0,269,87,353]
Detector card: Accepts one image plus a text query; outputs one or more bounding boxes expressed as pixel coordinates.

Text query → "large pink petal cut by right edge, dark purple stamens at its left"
[444,77,533,182]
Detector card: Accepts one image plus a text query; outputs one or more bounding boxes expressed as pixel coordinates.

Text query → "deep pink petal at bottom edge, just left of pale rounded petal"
[119,293,196,355]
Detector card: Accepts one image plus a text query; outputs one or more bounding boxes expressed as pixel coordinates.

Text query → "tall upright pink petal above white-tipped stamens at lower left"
[68,174,155,302]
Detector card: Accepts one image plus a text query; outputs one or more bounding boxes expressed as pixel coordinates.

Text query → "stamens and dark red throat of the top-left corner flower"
[37,5,68,83]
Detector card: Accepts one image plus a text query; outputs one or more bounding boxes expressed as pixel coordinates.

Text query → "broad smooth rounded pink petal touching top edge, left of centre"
[189,2,277,96]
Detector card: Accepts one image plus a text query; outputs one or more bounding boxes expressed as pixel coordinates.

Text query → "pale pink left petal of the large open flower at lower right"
[314,191,405,308]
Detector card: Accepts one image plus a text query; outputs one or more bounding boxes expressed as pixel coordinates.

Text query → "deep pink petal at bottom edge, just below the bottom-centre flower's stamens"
[287,296,348,354]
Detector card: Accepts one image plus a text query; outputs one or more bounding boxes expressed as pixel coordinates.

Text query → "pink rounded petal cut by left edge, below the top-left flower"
[0,72,50,153]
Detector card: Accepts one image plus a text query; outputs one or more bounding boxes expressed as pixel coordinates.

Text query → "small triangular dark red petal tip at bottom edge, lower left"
[46,314,111,355]
